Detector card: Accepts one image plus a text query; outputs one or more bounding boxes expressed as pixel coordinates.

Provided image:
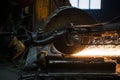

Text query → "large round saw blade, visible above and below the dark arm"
[45,7,96,54]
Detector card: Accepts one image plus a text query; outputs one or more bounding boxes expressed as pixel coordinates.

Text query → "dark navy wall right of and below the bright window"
[85,0,120,22]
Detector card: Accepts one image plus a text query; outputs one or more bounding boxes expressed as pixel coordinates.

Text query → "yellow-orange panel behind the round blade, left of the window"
[34,0,70,22]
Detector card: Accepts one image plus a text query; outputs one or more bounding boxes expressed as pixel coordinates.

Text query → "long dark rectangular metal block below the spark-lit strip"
[48,60,116,73]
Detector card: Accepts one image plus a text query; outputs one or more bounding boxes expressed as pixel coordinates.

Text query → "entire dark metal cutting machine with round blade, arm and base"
[1,7,120,80]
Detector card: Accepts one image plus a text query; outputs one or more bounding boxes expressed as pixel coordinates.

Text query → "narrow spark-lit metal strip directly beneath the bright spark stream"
[46,54,120,64]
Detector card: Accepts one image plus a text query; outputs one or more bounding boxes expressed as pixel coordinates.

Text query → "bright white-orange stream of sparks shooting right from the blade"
[74,45,120,57]
